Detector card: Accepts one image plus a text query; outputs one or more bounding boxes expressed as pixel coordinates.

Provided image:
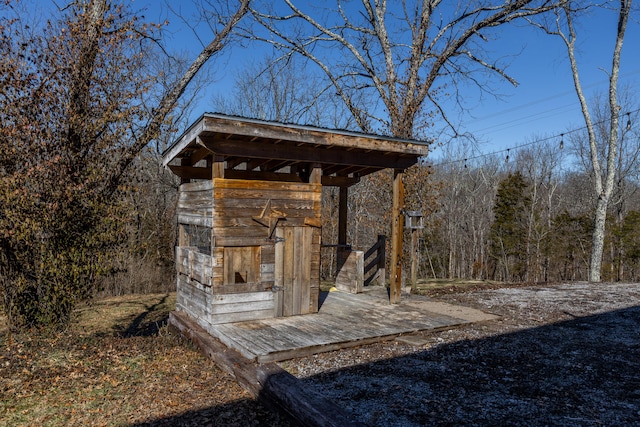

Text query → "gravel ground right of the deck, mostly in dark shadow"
[281,283,640,426]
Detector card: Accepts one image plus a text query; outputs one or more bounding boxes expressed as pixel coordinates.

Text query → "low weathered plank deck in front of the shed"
[209,287,496,363]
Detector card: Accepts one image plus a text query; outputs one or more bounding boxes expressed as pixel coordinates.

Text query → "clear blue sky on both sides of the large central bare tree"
[141,0,640,162]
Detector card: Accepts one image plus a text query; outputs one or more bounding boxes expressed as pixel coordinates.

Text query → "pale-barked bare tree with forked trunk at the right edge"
[542,0,632,282]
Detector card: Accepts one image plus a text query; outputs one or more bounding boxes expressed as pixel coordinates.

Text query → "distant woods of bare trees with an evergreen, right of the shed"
[419,130,640,282]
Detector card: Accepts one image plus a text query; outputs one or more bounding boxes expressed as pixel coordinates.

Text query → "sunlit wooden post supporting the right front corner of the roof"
[389,169,404,304]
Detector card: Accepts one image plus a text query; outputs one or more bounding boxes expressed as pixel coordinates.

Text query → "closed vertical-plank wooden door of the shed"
[274,227,313,317]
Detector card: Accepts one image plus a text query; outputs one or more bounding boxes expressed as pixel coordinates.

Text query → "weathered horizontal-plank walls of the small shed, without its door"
[176,178,321,327]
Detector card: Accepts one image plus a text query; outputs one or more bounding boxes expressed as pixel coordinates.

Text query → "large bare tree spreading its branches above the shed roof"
[252,0,558,138]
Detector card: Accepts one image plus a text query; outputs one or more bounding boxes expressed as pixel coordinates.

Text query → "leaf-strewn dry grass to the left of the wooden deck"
[0,294,286,426]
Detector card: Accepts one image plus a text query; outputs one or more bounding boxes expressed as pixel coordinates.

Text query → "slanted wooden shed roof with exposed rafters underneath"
[163,113,429,185]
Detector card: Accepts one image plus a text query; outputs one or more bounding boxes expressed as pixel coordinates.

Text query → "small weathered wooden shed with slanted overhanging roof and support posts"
[163,114,428,329]
